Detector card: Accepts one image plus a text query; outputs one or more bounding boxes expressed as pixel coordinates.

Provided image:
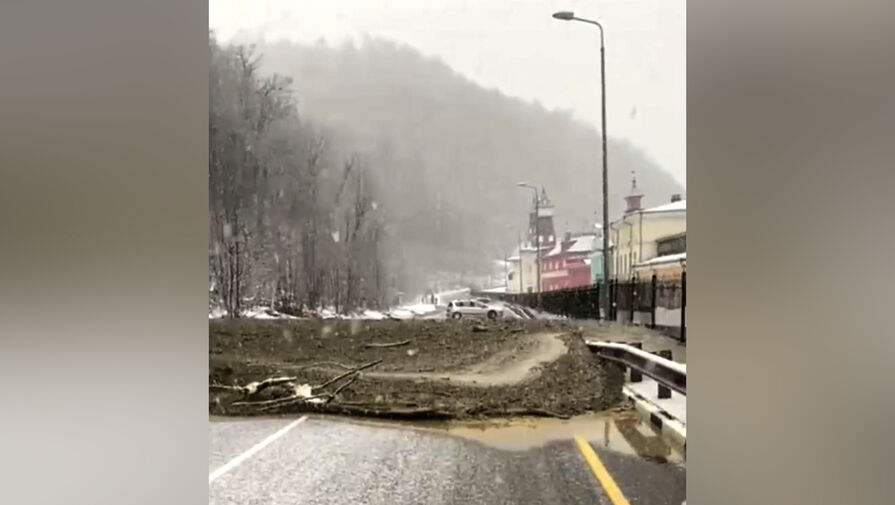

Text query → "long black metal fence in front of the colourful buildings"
[481,272,687,342]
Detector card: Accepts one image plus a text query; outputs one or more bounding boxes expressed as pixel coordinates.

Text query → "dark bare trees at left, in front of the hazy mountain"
[208,34,394,317]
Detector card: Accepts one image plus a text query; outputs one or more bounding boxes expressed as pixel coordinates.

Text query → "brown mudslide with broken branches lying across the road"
[209,320,623,419]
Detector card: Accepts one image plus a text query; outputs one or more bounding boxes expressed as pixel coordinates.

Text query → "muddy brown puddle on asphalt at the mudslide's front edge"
[443,411,683,463]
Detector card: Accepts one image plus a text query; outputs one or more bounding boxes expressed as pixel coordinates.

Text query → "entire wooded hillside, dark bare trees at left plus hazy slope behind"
[209,36,682,313]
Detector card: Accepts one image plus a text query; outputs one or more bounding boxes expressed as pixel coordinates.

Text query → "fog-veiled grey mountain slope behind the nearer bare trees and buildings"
[248,40,683,284]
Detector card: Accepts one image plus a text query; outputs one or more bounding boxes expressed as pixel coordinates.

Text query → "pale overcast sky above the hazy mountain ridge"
[209,0,687,185]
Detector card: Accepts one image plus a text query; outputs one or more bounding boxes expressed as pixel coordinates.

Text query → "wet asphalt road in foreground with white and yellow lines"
[209,416,686,505]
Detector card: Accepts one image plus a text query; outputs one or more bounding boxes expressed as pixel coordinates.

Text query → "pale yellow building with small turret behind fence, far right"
[609,191,687,280]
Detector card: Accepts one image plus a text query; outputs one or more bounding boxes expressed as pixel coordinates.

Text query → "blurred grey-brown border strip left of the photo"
[0,0,208,505]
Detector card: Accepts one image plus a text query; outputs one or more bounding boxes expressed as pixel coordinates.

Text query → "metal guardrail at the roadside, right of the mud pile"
[585,340,687,398]
